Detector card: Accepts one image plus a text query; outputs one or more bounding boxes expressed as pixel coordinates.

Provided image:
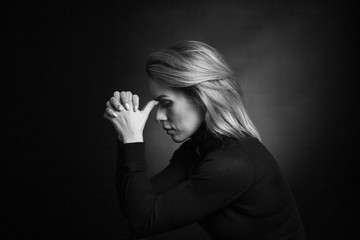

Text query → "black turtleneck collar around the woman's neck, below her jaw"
[191,122,223,156]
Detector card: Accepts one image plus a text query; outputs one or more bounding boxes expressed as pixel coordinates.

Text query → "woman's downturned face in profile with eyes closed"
[150,80,204,143]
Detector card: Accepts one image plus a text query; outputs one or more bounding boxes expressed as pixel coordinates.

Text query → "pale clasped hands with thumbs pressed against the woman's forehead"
[104,91,158,143]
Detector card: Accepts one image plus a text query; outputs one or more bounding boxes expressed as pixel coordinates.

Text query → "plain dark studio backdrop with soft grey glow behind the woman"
[1,1,359,239]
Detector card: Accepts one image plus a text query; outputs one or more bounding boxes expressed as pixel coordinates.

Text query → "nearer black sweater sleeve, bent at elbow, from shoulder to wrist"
[116,142,252,237]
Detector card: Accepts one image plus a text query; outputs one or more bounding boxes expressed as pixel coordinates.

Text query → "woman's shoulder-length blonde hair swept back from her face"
[146,41,261,140]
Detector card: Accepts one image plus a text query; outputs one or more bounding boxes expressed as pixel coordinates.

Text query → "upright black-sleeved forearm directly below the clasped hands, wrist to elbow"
[116,141,162,236]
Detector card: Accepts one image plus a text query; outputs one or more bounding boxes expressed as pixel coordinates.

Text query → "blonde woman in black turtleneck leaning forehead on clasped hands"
[104,41,306,240]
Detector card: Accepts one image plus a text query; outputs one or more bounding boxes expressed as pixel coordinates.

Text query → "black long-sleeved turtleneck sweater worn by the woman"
[116,127,306,240]
